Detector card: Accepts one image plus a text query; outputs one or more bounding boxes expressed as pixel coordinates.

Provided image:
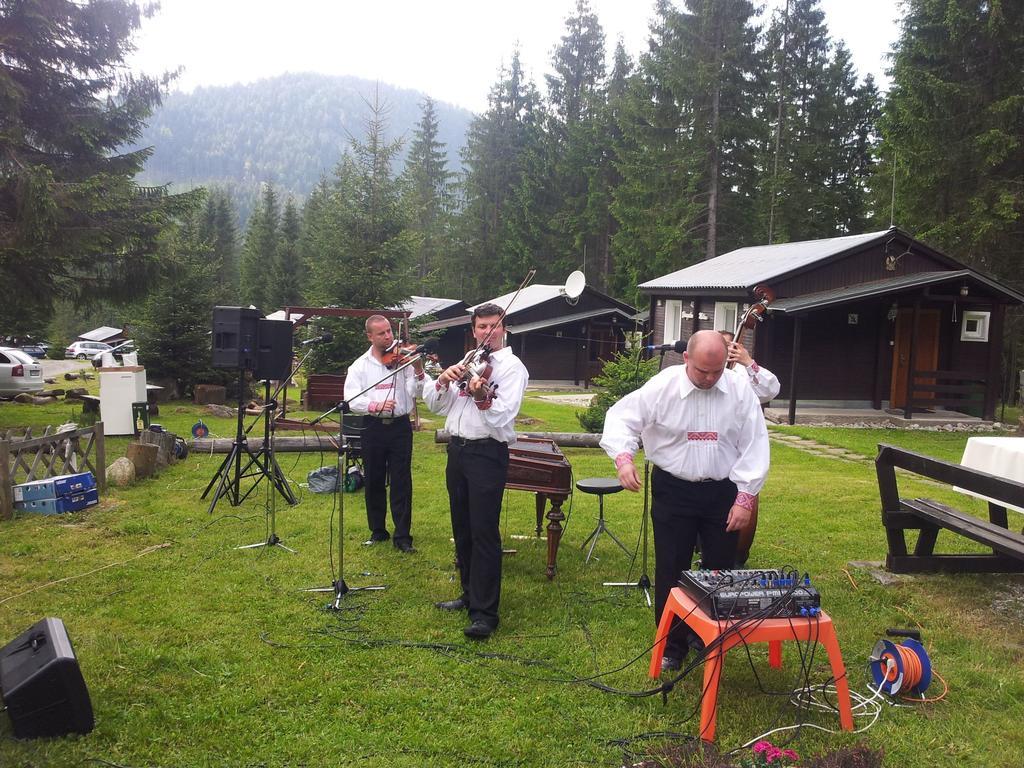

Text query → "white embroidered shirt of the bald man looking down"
[601,366,769,496]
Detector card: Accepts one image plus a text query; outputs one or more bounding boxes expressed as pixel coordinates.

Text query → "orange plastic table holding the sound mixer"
[648,587,853,741]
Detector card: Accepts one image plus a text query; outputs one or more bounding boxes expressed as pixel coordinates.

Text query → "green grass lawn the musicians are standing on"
[0,396,1024,768]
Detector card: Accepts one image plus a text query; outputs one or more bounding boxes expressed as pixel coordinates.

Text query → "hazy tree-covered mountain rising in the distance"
[135,73,473,226]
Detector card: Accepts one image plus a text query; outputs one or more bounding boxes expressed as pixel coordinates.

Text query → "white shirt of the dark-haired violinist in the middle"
[423,347,529,444]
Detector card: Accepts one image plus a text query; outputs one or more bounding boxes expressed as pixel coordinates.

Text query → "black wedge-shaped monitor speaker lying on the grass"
[0,618,93,738]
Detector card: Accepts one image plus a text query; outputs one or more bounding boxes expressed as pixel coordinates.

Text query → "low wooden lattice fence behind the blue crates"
[0,422,106,520]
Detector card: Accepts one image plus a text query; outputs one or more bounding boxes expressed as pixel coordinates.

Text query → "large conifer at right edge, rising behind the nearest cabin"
[879,0,1024,286]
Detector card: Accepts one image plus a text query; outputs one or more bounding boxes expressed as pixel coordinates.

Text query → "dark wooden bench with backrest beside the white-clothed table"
[874,443,1024,573]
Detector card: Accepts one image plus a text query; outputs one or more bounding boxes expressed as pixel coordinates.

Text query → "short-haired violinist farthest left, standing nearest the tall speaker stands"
[345,314,424,552]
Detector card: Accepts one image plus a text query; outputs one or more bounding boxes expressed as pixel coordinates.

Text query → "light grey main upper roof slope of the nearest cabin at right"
[639,229,895,289]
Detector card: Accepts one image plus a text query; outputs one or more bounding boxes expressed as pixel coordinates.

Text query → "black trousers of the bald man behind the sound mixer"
[650,467,739,658]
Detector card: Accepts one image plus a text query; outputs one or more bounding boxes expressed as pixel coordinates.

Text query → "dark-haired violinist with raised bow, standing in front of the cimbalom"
[423,304,529,640]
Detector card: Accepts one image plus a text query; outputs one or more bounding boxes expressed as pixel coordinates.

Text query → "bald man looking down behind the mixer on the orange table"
[601,331,769,670]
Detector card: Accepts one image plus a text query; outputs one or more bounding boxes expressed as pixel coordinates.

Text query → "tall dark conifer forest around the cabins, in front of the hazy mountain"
[0,0,1024,391]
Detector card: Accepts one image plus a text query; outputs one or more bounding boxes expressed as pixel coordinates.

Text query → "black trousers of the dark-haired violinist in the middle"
[444,437,509,628]
